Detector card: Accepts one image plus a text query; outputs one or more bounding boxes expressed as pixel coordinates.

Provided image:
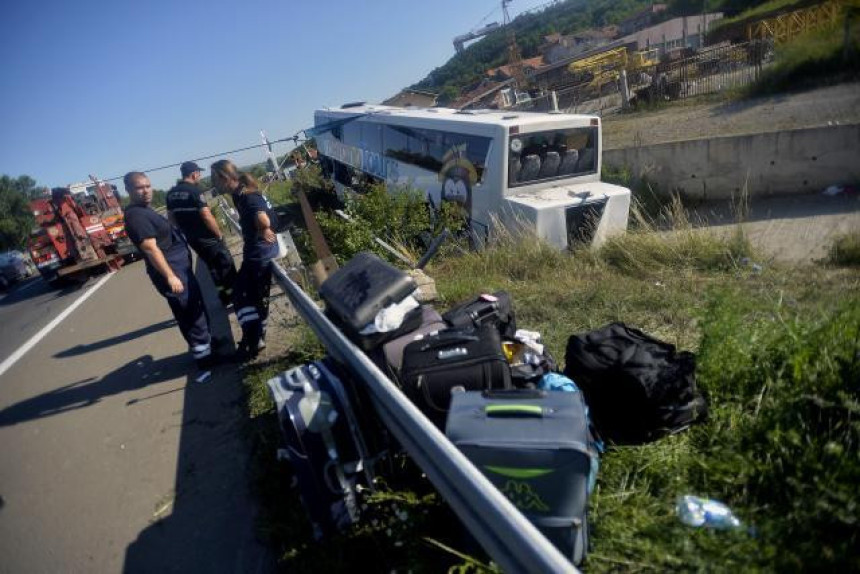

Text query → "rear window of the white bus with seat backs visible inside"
[508,127,598,188]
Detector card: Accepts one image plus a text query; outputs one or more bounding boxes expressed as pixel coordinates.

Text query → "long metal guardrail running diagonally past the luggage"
[224,197,577,573]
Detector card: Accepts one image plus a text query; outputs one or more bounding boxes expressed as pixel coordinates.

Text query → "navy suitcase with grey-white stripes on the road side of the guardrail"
[268,360,379,539]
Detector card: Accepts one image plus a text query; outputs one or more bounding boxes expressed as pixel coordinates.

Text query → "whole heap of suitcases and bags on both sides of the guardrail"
[269,253,704,564]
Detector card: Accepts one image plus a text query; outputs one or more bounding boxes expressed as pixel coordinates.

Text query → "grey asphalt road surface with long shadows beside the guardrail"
[0,263,271,572]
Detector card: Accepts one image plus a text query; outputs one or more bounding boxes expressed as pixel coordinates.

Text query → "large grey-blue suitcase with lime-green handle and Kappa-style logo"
[445,390,597,564]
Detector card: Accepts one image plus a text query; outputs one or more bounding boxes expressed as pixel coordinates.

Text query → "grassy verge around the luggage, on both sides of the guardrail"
[237,207,860,572]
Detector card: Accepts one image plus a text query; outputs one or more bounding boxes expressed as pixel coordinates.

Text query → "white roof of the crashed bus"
[317,104,598,126]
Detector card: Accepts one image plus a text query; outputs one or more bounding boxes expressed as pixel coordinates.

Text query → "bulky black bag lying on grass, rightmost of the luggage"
[564,323,708,444]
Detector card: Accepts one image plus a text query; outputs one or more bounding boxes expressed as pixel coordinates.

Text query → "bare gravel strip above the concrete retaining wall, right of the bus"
[603,82,860,150]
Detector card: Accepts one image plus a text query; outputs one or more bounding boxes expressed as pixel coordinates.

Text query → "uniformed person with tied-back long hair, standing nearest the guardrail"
[212,159,278,360]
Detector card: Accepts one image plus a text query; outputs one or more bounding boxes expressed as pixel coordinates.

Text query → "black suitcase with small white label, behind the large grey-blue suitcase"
[400,323,511,428]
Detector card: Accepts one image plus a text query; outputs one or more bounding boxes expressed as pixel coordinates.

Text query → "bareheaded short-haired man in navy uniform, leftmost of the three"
[123,171,215,381]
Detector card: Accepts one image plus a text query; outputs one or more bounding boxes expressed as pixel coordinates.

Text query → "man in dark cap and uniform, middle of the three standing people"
[167,161,236,306]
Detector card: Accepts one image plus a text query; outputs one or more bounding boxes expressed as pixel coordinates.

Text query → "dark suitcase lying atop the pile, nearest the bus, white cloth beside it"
[319,252,417,332]
